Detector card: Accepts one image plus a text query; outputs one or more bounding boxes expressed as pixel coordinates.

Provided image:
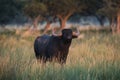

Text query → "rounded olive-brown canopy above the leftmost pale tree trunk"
[23,0,47,18]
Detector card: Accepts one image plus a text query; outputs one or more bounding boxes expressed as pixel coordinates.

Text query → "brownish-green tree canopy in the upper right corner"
[98,0,120,20]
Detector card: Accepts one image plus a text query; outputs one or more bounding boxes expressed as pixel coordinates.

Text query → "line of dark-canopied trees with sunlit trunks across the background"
[0,0,120,33]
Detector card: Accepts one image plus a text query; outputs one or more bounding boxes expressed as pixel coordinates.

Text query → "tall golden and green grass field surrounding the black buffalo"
[0,31,120,80]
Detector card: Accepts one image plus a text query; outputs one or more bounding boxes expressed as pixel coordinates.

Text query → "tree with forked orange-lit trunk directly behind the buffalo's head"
[46,0,85,29]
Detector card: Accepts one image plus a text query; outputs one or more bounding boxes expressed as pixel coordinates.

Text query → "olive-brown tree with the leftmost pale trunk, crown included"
[23,0,47,30]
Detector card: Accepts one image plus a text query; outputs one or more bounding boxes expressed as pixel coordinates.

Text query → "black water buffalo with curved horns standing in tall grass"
[34,29,79,64]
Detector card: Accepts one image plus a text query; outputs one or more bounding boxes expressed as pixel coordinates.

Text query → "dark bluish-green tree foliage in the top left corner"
[0,0,23,24]
